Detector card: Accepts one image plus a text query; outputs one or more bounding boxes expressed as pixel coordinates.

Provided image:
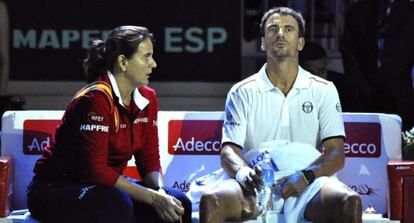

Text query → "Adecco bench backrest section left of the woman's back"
[1,111,63,209]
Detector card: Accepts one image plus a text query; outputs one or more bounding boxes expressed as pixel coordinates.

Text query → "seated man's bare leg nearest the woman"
[200,180,260,223]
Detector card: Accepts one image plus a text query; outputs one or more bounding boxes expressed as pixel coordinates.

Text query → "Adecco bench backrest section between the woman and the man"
[158,112,224,192]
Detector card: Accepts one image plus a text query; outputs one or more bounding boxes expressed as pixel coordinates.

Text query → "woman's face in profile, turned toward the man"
[125,38,157,85]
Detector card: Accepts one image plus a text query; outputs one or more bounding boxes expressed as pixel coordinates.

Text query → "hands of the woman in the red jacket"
[151,190,184,222]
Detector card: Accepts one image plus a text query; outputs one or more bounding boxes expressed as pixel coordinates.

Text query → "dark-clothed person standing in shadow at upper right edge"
[342,0,414,130]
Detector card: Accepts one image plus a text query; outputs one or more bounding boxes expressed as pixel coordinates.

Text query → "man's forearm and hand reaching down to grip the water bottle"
[220,143,264,192]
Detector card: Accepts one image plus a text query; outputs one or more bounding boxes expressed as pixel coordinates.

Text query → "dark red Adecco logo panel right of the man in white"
[345,122,381,158]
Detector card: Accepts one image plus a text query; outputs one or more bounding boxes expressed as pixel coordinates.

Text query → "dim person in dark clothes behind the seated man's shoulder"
[299,42,368,112]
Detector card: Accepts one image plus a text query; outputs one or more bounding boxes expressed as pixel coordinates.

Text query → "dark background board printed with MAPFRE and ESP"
[5,0,242,82]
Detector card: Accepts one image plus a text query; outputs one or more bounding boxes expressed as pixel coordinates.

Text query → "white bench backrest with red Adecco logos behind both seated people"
[1,111,401,213]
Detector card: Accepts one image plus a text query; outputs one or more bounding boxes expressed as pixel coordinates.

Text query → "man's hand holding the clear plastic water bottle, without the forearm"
[236,166,264,193]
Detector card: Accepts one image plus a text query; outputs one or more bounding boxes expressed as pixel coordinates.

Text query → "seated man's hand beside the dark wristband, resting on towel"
[276,171,308,199]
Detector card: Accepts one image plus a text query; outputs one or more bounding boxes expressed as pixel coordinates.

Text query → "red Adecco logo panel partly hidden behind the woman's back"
[23,120,60,155]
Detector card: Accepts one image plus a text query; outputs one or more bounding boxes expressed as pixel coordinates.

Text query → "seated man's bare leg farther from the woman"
[305,181,362,223]
